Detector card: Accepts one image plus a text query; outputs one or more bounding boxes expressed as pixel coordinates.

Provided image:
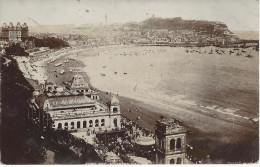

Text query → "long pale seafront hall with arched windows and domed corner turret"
[28,75,121,132]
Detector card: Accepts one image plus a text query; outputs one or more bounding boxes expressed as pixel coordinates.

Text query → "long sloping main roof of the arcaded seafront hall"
[45,96,95,109]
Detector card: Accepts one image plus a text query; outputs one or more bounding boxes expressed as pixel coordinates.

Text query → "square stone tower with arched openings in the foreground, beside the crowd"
[155,119,186,164]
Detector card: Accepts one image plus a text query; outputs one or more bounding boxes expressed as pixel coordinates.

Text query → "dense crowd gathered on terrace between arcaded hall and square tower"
[94,117,155,163]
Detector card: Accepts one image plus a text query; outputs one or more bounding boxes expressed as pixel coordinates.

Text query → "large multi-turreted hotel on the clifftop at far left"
[1,22,28,42]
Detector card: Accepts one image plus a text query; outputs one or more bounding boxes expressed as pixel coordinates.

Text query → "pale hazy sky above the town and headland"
[0,0,259,31]
